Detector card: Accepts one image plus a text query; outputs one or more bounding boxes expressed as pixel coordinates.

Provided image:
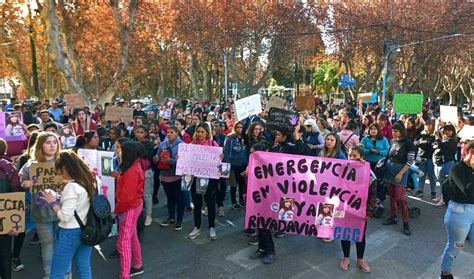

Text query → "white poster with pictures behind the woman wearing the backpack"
[77,149,115,211]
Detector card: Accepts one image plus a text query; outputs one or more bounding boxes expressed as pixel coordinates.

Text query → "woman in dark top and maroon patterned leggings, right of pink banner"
[383,122,416,235]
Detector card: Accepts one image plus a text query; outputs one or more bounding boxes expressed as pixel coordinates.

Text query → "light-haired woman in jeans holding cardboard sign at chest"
[20,132,61,278]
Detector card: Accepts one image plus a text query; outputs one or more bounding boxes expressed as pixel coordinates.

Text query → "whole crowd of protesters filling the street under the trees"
[0,95,474,279]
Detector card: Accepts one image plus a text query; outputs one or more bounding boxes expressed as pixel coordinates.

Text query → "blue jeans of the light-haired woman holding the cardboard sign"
[36,222,58,277]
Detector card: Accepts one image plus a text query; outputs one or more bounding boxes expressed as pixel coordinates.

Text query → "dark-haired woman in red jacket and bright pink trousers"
[114,140,145,279]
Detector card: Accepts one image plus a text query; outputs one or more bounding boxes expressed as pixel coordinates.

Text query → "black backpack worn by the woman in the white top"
[74,194,114,246]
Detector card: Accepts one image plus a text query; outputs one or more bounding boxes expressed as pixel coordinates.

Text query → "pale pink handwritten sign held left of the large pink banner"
[176,144,222,179]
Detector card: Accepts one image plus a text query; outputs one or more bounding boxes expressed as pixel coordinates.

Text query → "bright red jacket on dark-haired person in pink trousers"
[114,159,145,214]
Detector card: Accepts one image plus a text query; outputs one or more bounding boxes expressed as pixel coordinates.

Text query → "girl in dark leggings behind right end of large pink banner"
[339,146,377,273]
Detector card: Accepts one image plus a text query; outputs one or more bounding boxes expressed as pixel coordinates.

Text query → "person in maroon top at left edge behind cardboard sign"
[0,138,24,279]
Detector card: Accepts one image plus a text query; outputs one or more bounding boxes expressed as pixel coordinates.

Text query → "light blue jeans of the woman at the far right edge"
[441,201,474,273]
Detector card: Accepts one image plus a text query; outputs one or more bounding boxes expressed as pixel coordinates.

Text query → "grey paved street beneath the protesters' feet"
[13,188,474,279]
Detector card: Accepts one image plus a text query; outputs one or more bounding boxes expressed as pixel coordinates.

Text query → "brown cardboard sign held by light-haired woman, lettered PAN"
[30,163,64,194]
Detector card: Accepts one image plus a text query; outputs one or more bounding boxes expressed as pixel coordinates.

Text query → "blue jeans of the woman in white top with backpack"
[50,228,92,279]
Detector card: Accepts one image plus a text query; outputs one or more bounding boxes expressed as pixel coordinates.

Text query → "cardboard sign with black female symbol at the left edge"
[0,192,26,235]
